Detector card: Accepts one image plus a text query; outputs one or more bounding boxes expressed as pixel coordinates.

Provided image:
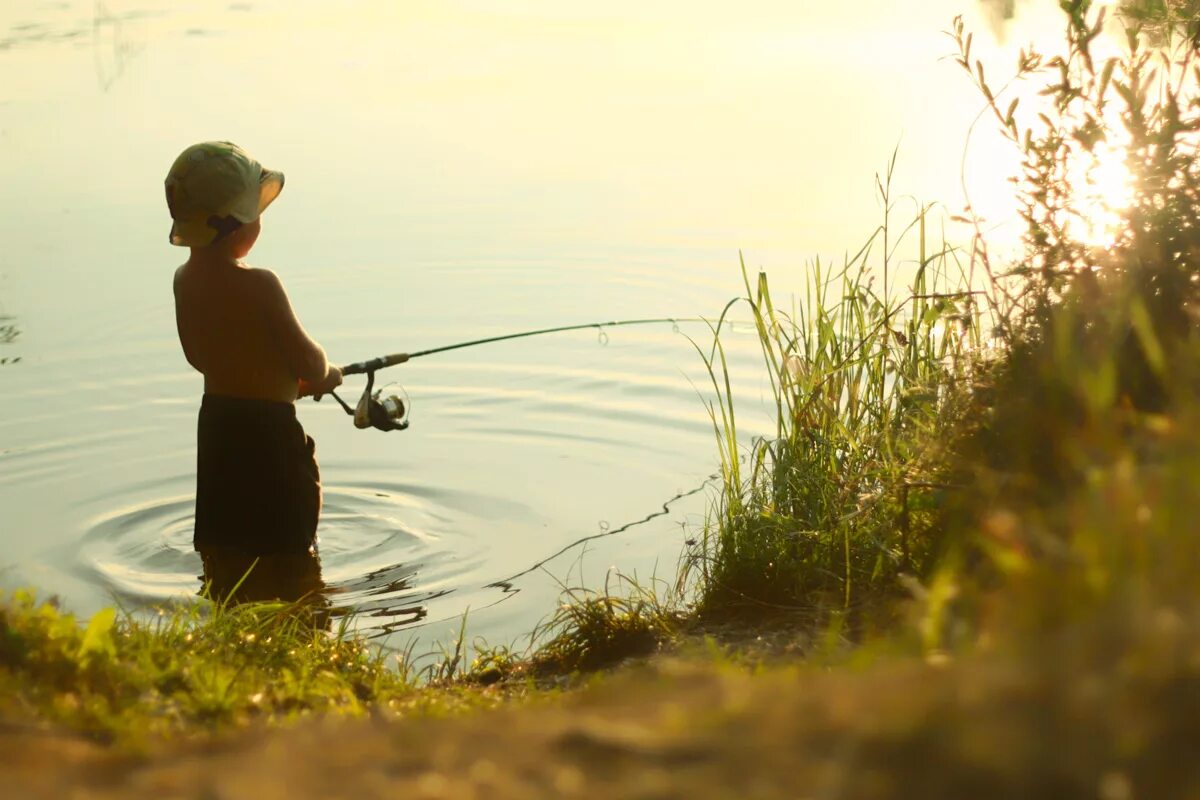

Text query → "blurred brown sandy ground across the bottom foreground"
[9,642,1200,800]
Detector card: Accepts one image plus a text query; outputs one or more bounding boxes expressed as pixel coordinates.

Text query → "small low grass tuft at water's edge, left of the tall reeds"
[529,576,680,674]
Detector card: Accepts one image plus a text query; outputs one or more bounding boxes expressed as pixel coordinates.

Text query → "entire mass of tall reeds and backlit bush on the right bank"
[686,0,1200,646]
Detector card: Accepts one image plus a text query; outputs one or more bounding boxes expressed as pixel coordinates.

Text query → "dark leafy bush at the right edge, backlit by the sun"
[902,0,1200,638]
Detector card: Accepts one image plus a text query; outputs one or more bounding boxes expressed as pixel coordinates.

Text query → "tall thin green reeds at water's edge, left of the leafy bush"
[685,158,985,610]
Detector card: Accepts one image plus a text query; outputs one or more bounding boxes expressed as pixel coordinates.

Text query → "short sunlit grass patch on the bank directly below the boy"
[0,591,413,742]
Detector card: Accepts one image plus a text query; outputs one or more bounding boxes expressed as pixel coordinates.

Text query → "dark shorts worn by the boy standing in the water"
[192,395,320,554]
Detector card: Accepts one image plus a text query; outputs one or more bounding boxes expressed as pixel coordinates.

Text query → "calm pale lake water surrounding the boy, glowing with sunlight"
[0,0,1070,657]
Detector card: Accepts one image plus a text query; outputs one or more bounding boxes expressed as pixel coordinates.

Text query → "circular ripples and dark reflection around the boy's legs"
[72,475,494,636]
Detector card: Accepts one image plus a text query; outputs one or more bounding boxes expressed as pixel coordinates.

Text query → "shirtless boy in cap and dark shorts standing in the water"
[166,142,342,568]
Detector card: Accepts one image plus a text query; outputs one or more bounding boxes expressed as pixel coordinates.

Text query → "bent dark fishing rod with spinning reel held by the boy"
[313,317,704,431]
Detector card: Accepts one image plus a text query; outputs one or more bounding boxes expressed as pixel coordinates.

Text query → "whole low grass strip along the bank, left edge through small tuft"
[0,568,678,750]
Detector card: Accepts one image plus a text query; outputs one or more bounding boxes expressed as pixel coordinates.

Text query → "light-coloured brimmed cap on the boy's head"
[167,142,283,247]
